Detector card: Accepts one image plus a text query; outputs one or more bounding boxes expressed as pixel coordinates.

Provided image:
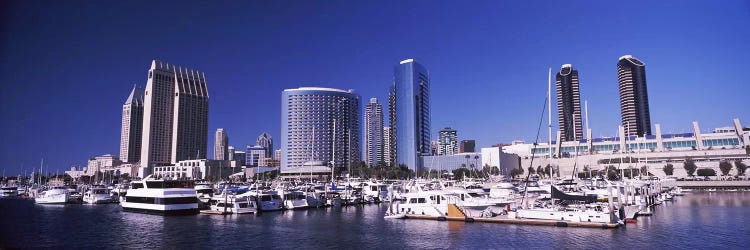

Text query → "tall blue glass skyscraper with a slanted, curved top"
[391,59,430,171]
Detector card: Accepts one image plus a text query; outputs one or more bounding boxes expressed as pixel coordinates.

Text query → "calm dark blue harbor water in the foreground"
[0,192,750,249]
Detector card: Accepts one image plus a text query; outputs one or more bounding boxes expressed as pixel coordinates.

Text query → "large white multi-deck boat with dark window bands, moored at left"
[120,175,198,215]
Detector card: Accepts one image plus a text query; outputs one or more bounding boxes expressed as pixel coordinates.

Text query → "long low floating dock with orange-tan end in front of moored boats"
[405,204,620,229]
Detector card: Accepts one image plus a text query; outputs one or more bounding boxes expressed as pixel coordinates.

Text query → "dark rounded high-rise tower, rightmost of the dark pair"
[617,55,651,136]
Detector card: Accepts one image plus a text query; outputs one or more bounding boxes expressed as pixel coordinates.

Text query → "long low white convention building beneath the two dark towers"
[503,119,750,177]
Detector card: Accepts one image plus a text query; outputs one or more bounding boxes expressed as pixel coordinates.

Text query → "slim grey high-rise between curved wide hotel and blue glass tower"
[362,98,383,166]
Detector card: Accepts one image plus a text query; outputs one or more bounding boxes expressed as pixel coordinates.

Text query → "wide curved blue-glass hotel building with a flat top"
[281,87,361,171]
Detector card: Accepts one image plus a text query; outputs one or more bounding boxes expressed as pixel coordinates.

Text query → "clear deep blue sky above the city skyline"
[0,0,750,174]
